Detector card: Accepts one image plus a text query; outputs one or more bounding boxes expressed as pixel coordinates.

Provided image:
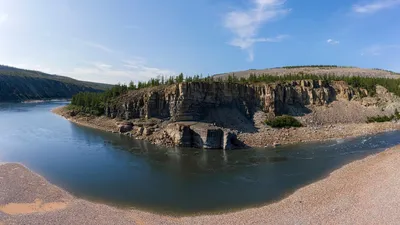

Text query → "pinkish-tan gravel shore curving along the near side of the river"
[0,146,400,225]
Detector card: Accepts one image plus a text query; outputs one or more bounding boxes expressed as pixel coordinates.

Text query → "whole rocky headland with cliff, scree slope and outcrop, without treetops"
[58,80,400,149]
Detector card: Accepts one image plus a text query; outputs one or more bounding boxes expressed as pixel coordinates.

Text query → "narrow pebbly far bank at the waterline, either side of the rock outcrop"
[52,106,400,147]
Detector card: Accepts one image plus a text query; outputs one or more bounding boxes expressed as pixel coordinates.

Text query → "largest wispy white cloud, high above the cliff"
[224,0,290,61]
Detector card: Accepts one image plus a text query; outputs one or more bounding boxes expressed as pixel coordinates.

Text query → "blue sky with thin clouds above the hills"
[0,0,400,84]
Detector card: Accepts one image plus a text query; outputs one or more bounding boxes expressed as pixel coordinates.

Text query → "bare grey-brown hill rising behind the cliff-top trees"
[214,65,400,78]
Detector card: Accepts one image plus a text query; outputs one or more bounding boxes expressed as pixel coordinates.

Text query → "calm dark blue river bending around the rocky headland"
[0,102,400,214]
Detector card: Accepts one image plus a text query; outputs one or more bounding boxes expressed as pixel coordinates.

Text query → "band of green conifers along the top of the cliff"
[71,72,400,115]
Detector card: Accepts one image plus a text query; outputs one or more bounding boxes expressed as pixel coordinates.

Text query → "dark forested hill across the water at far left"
[0,65,112,102]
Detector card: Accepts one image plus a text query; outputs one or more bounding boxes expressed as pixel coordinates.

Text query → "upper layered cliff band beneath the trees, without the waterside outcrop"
[105,80,356,121]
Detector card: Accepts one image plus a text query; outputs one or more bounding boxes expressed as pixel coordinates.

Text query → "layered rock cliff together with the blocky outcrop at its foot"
[99,80,362,149]
